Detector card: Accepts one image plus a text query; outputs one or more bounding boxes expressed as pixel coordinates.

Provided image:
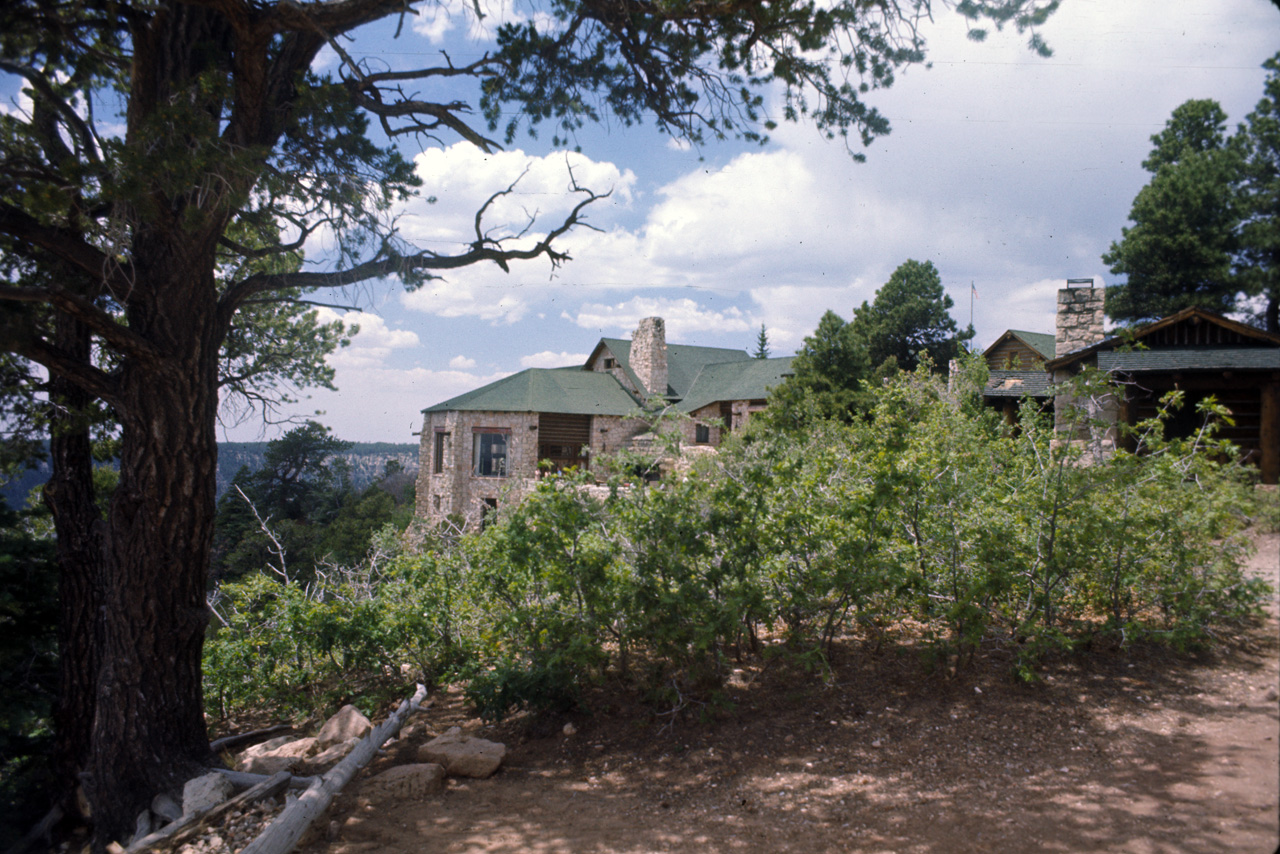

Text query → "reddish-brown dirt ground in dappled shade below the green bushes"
[307,534,1280,854]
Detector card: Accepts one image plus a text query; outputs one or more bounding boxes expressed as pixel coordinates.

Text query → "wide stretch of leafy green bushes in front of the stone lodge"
[206,364,1267,720]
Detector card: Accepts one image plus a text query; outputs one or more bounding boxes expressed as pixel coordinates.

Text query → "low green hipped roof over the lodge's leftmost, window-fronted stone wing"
[422,367,640,415]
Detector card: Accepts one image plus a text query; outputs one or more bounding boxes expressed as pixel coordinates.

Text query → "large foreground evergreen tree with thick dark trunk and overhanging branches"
[0,0,1057,850]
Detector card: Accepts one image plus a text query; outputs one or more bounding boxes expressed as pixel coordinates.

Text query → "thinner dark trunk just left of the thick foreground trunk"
[44,315,102,814]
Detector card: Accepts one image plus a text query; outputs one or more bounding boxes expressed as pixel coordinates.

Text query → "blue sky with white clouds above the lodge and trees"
[9,0,1280,442]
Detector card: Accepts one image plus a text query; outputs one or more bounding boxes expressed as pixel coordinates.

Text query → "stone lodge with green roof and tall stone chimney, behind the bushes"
[416,318,791,524]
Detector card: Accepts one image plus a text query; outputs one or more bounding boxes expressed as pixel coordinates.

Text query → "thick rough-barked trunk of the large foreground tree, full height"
[76,4,240,850]
